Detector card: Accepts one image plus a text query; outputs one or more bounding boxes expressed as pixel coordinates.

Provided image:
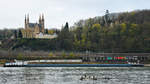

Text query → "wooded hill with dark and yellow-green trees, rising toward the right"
[3,10,150,53]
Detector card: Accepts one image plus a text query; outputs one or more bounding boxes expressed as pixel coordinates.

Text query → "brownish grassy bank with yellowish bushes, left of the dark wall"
[0,50,82,60]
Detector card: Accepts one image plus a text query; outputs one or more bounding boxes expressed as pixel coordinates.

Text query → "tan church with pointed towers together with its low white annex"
[22,15,57,39]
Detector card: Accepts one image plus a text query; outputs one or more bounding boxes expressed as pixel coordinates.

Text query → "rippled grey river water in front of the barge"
[0,67,150,84]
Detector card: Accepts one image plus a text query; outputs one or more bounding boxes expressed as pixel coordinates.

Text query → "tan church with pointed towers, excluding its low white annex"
[22,15,45,38]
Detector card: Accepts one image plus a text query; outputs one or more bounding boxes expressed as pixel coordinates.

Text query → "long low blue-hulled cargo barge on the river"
[4,63,144,67]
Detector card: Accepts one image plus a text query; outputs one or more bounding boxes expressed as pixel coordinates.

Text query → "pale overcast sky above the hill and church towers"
[0,0,150,29]
